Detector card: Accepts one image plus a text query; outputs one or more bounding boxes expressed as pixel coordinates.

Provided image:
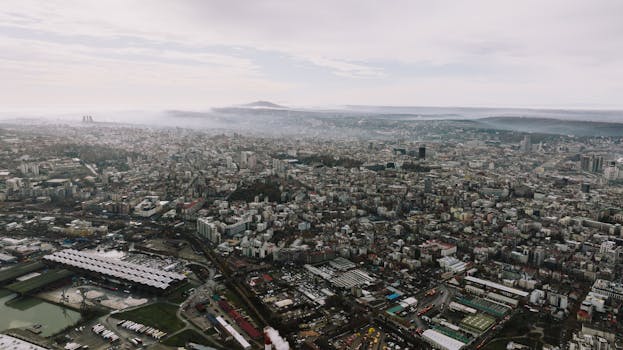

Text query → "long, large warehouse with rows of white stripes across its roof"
[43,249,186,292]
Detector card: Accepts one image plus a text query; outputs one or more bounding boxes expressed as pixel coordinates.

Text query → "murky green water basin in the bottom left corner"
[0,289,80,337]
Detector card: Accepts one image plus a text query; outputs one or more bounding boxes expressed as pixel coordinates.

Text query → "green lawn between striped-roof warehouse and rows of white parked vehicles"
[114,303,184,333]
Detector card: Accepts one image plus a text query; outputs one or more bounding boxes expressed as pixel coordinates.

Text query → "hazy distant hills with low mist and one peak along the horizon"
[167,101,623,138]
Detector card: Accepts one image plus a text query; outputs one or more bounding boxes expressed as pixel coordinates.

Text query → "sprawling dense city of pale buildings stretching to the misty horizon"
[0,108,623,350]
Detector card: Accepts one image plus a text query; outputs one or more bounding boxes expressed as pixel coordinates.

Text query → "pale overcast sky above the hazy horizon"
[0,0,623,111]
